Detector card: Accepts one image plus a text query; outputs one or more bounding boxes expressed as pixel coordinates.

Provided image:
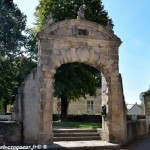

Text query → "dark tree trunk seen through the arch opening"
[60,96,69,121]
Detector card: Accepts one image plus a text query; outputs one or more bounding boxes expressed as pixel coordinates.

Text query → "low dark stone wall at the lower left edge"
[0,121,22,144]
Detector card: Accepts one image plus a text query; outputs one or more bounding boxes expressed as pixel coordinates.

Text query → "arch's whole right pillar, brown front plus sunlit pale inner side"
[102,72,127,144]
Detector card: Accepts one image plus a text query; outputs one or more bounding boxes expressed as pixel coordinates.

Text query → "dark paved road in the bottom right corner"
[124,135,150,150]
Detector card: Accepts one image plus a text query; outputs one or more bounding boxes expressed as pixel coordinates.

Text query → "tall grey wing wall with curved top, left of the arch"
[12,67,43,143]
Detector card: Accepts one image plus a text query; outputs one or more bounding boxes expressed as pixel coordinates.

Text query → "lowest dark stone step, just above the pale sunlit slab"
[53,136,100,141]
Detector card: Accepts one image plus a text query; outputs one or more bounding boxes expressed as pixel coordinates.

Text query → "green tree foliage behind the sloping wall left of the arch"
[0,56,36,112]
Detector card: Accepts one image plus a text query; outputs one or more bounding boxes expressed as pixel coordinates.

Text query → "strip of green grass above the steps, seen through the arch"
[53,122,102,129]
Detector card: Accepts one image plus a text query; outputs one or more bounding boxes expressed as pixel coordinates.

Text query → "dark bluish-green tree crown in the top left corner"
[0,0,26,58]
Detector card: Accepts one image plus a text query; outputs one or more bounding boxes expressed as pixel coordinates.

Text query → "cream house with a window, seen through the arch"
[53,88,102,115]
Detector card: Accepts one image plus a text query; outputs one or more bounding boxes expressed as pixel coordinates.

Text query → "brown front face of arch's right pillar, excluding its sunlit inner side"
[110,74,127,144]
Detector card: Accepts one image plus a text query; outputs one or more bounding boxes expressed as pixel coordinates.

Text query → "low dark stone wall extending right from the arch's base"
[127,119,150,143]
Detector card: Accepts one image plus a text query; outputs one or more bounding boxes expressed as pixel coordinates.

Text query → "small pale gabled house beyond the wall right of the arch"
[127,103,144,115]
